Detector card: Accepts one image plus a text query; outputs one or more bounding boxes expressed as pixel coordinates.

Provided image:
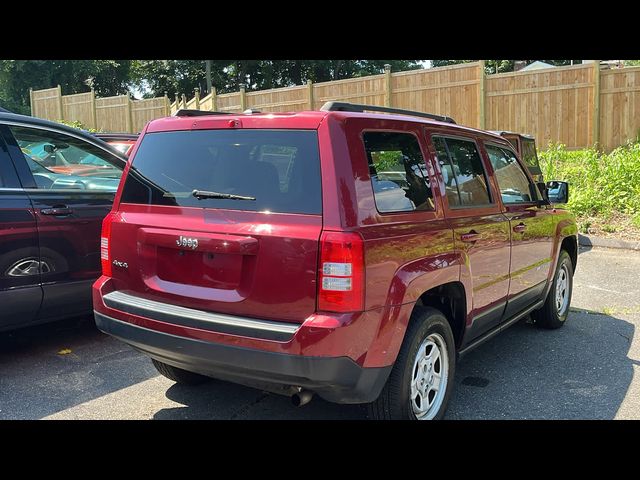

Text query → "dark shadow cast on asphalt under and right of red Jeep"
[154,309,634,420]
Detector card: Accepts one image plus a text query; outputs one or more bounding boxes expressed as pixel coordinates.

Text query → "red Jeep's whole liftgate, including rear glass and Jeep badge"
[110,129,322,322]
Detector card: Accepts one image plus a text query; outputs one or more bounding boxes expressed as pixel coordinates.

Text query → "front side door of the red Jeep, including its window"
[485,143,555,319]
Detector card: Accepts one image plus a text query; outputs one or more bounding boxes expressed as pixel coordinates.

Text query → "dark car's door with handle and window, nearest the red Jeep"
[3,125,125,319]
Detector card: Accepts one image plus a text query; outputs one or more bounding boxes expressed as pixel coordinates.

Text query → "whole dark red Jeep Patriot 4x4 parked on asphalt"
[93,102,577,419]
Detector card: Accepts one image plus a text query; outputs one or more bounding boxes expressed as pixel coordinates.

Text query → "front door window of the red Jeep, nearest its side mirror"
[486,145,535,204]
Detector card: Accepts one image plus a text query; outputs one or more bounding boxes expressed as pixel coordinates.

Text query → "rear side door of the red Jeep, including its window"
[431,132,510,343]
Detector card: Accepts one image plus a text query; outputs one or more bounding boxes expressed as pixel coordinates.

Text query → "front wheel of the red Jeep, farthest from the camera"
[531,250,573,329]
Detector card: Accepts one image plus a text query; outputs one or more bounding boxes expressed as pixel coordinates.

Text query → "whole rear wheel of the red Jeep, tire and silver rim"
[369,307,456,420]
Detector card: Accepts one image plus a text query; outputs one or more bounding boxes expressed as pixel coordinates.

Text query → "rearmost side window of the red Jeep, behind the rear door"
[363,132,434,213]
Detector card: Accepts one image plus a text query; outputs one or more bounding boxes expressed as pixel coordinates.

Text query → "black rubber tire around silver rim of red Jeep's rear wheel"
[368,307,456,420]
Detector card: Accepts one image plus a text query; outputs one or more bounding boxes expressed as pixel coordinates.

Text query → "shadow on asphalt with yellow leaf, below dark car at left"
[0,317,157,419]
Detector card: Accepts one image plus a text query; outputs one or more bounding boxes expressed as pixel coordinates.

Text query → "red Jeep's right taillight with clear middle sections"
[318,232,364,312]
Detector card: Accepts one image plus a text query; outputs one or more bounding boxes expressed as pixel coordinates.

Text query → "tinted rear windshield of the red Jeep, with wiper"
[121,130,322,214]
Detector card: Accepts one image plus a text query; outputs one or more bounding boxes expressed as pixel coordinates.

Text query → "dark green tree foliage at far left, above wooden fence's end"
[0,60,131,113]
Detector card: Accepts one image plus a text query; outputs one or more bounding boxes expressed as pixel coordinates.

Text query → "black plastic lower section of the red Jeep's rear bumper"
[94,311,391,403]
